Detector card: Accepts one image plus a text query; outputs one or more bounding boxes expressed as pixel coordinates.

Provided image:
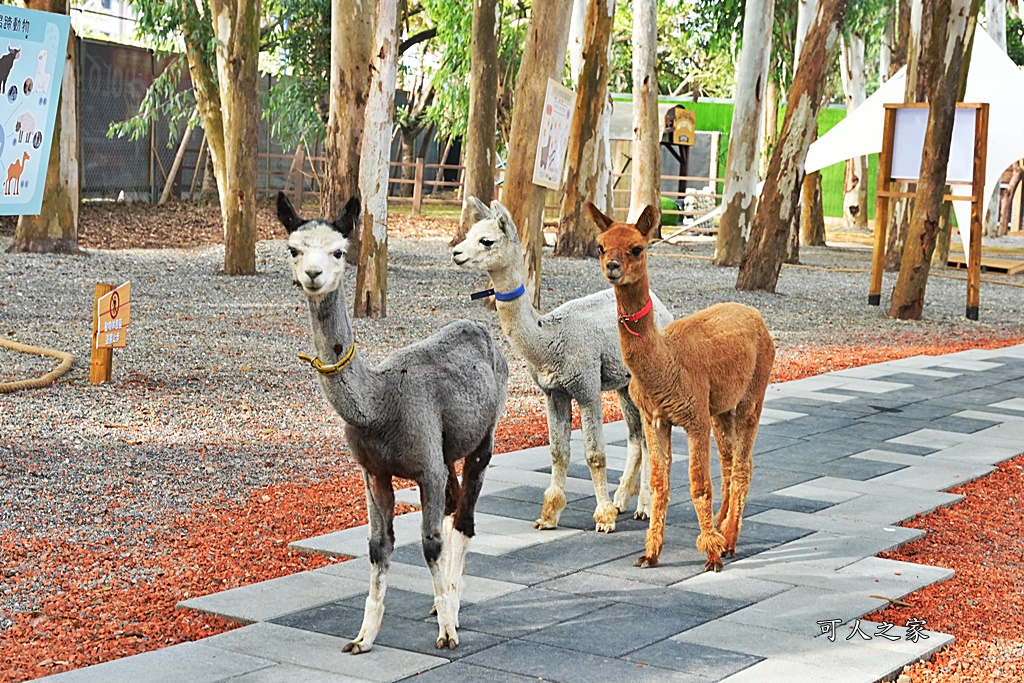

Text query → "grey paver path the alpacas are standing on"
[36,346,1024,683]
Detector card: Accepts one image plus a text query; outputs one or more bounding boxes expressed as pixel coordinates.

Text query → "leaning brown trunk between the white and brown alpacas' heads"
[554,0,615,258]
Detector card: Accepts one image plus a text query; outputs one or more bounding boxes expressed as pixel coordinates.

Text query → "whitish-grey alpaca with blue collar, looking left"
[452,197,673,531]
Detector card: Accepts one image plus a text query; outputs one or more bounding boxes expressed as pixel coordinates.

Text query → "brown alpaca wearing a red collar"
[587,203,775,571]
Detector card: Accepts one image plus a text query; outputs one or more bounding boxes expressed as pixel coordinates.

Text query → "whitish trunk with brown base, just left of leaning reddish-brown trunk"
[715,0,774,266]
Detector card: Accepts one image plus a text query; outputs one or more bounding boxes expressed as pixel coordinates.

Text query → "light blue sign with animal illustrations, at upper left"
[0,5,71,215]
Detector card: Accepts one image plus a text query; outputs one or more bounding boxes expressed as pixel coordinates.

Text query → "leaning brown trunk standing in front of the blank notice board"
[889,0,971,319]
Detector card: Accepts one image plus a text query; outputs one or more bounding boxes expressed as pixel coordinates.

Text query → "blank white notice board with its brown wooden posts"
[867,102,988,321]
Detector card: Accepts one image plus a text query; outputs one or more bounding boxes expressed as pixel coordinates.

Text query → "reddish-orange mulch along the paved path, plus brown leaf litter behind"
[0,206,1024,683]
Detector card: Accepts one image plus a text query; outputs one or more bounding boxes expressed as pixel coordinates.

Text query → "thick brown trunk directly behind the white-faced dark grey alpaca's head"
[321,0,374,232]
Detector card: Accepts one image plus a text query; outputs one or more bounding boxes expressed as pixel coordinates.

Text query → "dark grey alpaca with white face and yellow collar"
[278,194,508,654]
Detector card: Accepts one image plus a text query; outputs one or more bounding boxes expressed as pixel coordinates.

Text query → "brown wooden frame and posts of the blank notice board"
[867,102,988,321]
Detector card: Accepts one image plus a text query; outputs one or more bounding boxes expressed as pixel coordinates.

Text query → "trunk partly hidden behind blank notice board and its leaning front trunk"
[885,0,937,272]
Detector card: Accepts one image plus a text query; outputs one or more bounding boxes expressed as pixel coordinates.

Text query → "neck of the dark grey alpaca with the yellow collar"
[306,287,384,429]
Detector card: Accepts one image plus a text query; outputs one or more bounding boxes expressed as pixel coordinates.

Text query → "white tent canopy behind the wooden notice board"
[804,31,1024,260]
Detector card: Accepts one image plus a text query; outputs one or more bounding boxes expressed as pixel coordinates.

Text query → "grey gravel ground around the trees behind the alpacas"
[0,233,1024,630]
